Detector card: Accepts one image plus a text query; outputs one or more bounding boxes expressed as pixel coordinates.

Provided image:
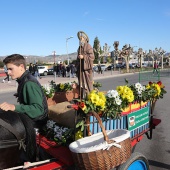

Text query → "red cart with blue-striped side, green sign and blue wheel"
[6,102,161,170]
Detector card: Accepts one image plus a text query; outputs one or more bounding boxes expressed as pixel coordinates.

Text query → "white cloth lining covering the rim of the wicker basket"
[69,129,130,153]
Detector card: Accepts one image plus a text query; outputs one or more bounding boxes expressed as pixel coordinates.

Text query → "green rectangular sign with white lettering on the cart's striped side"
[127,106,149,131]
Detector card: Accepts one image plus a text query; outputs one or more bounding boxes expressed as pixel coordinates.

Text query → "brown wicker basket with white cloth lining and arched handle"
[69,112,131,170]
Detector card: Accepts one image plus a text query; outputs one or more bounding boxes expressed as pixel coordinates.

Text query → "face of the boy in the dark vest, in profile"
[6,63,25,80]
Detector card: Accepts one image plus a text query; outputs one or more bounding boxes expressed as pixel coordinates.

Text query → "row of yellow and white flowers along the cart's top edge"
[77,81,166,119]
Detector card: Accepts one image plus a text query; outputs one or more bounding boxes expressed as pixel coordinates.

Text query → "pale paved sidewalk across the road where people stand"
[0,71,131,93]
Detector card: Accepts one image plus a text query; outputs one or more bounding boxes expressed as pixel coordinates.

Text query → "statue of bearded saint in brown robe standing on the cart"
[76,31,95,97]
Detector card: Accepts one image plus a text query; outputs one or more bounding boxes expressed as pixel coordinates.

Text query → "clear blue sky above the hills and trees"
[0,0,170,56]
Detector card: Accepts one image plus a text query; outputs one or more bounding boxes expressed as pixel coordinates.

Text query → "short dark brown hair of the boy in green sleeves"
[3,54,26,69]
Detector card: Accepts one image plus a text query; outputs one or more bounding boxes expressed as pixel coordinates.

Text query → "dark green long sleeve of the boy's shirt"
[15,81,44,118]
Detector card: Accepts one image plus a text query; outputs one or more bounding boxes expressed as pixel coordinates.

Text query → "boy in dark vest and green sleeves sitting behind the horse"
[0,54,48,128]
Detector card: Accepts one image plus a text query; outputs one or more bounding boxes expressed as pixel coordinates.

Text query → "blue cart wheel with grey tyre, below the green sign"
[117,152,149,170]
